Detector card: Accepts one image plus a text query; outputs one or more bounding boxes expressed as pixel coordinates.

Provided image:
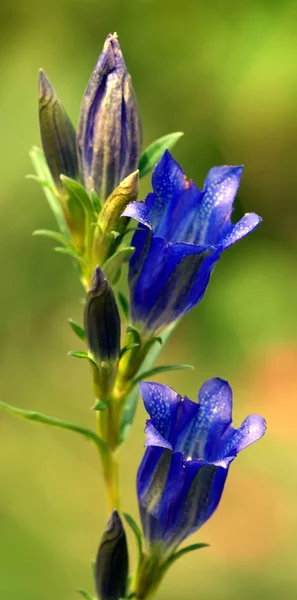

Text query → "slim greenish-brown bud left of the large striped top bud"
[38,69,78,188]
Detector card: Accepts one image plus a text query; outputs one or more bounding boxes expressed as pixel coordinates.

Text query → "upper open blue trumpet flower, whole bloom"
[123,151,261,333]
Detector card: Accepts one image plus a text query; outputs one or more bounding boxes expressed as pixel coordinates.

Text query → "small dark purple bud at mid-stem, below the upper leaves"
[84,266,121,366]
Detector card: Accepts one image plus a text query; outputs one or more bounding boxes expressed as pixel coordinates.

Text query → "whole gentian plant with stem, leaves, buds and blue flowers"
[0,34,266,600]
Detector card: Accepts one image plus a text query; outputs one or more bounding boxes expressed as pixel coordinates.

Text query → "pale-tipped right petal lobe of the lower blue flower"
[217,415,266,460]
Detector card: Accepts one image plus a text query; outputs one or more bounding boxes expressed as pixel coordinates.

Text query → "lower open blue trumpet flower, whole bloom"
[137,379,266,557]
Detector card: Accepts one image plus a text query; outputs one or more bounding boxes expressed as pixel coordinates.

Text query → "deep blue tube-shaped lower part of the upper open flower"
[129,237,220,331]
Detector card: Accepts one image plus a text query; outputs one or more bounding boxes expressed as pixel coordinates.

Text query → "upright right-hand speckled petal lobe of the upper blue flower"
[195,166,243,245]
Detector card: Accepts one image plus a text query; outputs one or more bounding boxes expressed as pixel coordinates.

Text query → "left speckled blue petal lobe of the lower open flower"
[139,381,181,440]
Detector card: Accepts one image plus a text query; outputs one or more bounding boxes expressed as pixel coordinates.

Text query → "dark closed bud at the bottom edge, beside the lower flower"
[95,510,128,600]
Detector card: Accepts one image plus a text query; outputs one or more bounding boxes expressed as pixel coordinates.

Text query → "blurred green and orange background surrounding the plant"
[0,0,297,600]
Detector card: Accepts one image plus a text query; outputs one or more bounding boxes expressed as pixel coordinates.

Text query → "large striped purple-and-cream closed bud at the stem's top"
[77,34,141,201]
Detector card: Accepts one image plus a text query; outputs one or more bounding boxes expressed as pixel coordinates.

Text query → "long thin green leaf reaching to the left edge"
[0,401,109,454]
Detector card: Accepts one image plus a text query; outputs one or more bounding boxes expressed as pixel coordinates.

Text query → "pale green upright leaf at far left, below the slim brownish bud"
[30,146,71,240]
